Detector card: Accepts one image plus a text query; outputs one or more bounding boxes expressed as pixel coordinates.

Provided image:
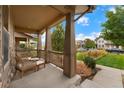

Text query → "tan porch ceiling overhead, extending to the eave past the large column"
[11,5,94,33]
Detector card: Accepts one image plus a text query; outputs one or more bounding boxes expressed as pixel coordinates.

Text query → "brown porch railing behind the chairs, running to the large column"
[16,49,63,68]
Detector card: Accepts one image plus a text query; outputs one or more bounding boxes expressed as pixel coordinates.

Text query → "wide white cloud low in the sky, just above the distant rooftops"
[76,31,100,40]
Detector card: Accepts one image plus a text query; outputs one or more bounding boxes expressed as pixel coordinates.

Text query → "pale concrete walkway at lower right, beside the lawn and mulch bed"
[80,65,124,88]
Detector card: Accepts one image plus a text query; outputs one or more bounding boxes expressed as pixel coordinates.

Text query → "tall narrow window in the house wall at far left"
[2,5,9,65]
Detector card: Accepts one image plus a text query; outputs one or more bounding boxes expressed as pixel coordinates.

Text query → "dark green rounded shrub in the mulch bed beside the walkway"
[84,56,96,69]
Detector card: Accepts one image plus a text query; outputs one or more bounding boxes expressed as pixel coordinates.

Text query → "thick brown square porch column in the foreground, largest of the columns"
[63,12,76,78]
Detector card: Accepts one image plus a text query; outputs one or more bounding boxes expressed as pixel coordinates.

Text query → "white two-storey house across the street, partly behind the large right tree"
[95,37,122,49]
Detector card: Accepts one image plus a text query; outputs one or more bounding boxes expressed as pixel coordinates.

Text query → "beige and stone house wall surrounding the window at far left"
[0,6,15,87]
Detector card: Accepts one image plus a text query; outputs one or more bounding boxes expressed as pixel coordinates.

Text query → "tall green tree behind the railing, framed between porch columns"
[52,24,65,52]
